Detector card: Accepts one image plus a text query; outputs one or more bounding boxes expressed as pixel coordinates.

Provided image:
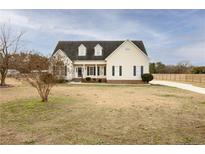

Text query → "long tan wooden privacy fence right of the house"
[153,74,205,83]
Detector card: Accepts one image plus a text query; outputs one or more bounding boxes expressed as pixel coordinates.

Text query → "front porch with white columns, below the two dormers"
[73,64,106,79]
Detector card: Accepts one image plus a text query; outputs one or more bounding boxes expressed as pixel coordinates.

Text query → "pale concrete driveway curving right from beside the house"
[150,80,205,94]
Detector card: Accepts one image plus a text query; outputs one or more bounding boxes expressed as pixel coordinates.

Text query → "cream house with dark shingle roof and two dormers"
[52,40,149,83]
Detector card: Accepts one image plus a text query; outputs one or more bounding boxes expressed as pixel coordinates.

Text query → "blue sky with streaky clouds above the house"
[0,10,205,65]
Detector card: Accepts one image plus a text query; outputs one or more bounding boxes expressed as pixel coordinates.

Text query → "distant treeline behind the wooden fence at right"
[149,62,205,74]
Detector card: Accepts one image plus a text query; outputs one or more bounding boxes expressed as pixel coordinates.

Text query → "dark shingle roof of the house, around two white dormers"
[53,41,147,60]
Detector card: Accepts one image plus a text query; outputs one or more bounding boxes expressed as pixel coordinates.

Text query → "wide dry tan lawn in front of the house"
[0,79,205,144]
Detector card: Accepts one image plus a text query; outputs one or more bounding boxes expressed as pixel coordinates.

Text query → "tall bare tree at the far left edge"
[0,24,24,86]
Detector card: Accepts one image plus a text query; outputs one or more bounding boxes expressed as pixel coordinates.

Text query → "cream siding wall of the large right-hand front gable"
[106,41,149,80]
